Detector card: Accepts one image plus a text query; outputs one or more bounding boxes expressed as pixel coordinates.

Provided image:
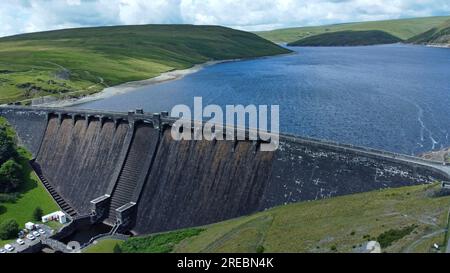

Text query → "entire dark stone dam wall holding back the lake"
[0,106,450,234]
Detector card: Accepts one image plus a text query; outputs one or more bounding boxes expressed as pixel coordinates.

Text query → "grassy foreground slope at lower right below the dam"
[88,184,450,253]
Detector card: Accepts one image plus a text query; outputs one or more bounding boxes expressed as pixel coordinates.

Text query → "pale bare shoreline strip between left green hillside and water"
[33,59,232,108]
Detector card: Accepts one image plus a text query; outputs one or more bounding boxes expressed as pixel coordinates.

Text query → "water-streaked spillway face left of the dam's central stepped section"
[35,116,128,214]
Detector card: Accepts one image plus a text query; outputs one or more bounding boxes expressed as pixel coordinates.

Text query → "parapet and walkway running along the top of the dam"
[0,105,450,180]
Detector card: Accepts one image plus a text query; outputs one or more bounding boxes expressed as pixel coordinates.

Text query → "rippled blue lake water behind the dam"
[77,45,450,154]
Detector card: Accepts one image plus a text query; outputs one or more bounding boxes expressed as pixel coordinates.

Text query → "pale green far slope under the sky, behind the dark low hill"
[257,16,450,43]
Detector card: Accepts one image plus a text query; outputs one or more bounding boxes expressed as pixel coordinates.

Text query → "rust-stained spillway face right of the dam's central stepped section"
[135,130,274,233]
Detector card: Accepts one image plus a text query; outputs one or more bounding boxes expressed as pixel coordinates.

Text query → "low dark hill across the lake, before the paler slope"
[288,30,402,46]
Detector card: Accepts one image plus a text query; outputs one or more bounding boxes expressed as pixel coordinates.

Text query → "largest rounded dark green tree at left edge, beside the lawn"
[0,159,22,193]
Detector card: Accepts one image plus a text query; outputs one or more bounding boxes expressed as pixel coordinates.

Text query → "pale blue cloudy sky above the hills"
[0,0,450,37]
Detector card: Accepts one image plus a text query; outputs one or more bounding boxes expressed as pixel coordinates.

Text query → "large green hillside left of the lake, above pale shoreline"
[0,25,288,103]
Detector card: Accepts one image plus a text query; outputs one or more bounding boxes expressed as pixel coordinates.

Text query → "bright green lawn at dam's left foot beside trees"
[0,118,59,244]
